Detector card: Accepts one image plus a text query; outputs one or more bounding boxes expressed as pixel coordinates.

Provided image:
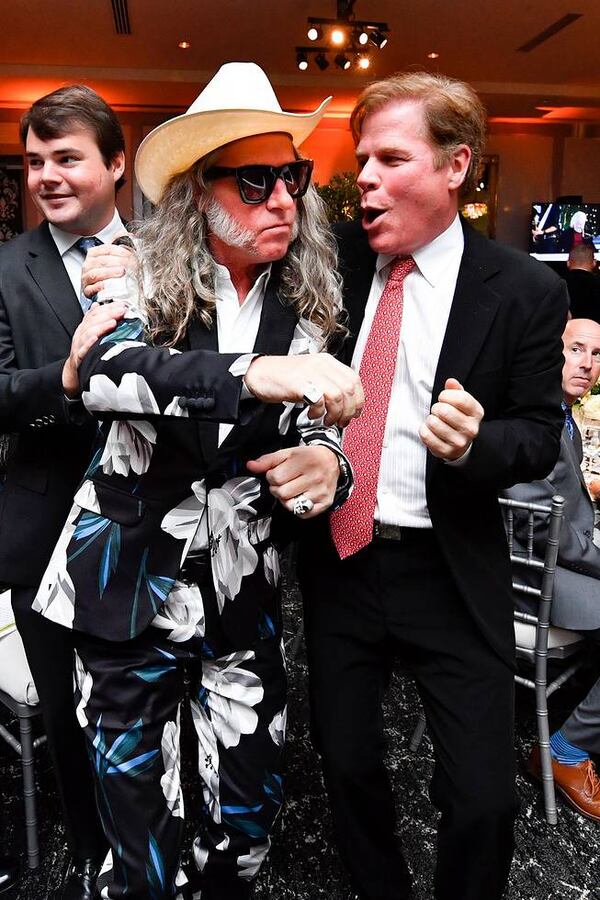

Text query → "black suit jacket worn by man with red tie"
[302,223,568,664]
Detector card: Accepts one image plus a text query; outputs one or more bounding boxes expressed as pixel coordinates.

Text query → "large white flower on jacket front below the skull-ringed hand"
[208,476,260,612]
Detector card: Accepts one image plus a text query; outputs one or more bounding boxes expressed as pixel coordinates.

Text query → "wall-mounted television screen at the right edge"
[529,203,600,262]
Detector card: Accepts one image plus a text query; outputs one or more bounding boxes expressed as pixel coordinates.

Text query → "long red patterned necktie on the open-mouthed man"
[331,256,415,559]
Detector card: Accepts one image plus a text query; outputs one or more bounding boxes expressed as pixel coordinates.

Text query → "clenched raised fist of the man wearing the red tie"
[419,378,484,462]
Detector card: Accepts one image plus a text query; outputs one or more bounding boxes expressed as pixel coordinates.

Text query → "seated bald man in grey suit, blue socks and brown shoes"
[506,319,600,821]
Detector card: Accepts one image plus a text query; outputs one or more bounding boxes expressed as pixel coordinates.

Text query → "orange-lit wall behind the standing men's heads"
[0,77,600,250]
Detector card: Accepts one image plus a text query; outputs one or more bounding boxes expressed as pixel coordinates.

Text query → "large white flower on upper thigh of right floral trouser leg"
[202,650,264,748]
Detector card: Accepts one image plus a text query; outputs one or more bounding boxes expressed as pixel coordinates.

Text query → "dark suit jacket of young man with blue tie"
[0,222,96,587]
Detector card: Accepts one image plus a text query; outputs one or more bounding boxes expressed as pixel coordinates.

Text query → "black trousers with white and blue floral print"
[76,600,286,900]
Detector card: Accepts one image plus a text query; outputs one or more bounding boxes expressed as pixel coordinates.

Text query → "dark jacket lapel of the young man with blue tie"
[26,222,83,335]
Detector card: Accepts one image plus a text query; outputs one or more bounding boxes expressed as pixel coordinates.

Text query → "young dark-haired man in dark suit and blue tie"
[0,85,125,900]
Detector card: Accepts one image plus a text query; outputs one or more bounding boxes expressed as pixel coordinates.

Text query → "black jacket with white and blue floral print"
[34,279,352,646]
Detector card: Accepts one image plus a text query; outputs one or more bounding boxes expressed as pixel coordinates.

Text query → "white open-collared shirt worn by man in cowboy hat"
[215,263,271,446]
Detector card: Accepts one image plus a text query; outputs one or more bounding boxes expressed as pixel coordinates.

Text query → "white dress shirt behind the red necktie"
[352,215,464,528]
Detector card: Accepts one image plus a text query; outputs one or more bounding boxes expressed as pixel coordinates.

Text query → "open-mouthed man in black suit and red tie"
[300,72,567,900]
